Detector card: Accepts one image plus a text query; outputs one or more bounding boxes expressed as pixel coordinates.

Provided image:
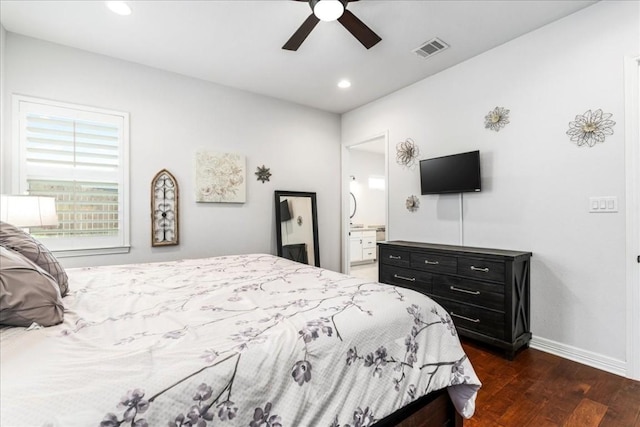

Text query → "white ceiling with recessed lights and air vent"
[0,0,595,113]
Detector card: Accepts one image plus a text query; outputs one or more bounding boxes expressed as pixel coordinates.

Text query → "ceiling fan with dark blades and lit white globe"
[282,0,382,50]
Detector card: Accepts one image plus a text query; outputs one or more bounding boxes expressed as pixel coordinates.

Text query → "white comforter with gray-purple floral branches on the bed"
[0,254,480,427]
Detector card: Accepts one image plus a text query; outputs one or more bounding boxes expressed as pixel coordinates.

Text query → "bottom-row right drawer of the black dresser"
[436,298,505,339]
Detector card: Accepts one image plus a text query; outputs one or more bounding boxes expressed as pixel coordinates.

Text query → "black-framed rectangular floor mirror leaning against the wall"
[275,191,320,267]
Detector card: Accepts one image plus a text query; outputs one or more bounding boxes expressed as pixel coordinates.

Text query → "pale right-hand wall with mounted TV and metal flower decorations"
[342,1,640,373]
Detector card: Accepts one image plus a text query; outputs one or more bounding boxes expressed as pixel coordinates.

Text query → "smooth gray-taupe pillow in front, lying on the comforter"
[0,246,64,327]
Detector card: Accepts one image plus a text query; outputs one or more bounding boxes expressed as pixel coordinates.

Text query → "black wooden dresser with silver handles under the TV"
[378,241,531,359]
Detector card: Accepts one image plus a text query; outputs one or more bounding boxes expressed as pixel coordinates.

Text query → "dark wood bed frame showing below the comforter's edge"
[374,389,462,427]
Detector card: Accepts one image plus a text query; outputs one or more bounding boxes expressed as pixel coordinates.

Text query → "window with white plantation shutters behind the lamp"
[13,96,129,256]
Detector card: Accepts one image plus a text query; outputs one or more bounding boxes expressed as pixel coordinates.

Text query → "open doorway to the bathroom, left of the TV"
[343,132,388,281]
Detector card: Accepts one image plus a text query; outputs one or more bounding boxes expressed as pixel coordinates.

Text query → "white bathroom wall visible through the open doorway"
[349,149,386,225]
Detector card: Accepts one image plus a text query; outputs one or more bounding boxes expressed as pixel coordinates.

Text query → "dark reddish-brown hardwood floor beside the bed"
[463,340,640,427]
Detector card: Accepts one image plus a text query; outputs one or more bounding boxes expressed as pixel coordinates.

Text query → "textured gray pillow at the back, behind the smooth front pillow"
[0,221,69,297]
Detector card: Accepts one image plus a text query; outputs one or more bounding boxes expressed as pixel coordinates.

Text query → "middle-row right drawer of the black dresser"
[432,275,504,311]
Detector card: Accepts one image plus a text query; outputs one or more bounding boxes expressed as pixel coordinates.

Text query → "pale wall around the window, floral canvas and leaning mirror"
[2,33,340,270]
